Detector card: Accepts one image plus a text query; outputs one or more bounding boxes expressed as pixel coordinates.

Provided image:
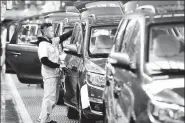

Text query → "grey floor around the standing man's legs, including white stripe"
[1,71,77,123]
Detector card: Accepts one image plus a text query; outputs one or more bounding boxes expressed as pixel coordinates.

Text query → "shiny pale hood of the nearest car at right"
[144,78,184,106]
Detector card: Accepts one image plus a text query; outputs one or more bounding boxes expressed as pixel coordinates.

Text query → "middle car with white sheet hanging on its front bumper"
[64,2,122,123]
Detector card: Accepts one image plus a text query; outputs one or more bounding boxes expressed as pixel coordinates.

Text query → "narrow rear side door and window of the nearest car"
[104,20,128,122]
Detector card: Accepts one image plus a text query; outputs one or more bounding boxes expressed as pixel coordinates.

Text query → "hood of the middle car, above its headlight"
[85,58,107,74]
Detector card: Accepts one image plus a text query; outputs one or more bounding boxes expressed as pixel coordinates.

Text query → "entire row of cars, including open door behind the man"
[4,1,185,123]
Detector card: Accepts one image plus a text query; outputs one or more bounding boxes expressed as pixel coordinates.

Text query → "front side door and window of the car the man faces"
[64,23,83,108]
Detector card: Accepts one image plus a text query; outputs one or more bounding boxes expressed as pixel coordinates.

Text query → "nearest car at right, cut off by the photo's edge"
[103,2,185,123]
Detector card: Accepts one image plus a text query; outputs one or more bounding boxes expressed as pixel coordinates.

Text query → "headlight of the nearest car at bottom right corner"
[148,101,184,122]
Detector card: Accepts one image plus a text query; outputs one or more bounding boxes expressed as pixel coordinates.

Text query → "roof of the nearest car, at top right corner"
[125,1,184,24]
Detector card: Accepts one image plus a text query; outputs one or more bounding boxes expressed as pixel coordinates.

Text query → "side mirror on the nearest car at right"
[108,52,131,70]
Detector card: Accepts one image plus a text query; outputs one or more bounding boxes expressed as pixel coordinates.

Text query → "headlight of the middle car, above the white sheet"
[87,73,105,87]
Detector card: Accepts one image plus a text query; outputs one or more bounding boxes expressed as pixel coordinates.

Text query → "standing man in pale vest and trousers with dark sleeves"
[38,23,72,123]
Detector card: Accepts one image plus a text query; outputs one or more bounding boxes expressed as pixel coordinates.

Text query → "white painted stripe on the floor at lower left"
[6,74,33,123]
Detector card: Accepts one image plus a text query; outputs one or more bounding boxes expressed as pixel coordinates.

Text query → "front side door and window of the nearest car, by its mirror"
[110,19,136,123]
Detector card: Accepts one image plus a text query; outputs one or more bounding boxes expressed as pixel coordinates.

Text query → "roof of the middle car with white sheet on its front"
[81,1,123,25]
